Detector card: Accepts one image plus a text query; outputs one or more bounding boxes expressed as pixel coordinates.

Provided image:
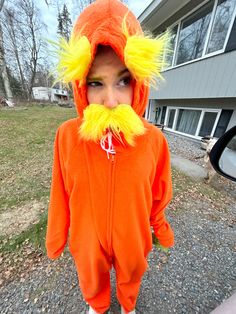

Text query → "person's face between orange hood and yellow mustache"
[87,47,133,108]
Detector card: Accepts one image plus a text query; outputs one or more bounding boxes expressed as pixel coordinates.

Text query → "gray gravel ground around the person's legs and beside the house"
[0,134,236,314]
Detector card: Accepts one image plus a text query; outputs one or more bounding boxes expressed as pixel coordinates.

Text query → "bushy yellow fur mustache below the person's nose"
[79,104,145,146]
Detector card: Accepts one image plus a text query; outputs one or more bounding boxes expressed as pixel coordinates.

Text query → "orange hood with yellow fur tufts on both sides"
[55,0,169,117]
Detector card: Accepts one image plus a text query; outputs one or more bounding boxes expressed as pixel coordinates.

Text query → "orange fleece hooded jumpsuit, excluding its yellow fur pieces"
[46,0,174,313]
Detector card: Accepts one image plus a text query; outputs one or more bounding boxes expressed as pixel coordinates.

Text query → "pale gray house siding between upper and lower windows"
[150,51,236,99]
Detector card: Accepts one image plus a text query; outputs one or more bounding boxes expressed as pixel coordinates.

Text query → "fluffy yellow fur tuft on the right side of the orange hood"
[122,21,170,87]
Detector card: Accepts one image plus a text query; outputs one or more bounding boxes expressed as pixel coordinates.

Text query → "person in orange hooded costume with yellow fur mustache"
[46,0,174,314]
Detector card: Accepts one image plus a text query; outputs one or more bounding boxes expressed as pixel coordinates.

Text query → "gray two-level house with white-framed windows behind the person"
[139,0,236,139]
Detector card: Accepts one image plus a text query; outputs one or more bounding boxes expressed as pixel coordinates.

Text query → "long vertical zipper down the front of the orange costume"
[107,154,115,255]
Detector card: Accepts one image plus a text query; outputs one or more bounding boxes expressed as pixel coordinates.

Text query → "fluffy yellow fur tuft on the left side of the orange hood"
[51,34,92,84]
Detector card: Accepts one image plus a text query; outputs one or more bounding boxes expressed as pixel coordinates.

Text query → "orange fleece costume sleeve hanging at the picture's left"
[46,129,70,259]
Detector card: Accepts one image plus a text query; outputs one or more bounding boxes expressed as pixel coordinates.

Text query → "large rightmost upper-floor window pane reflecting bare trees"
[207,0,236,53]
